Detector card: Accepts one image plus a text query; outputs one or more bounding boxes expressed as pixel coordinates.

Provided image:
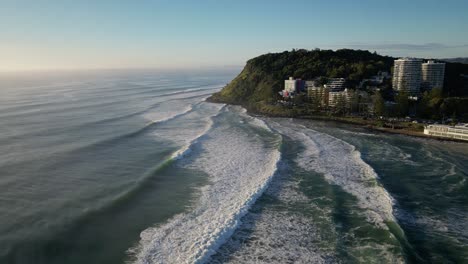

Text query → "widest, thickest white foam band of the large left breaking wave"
[131,108,280,263]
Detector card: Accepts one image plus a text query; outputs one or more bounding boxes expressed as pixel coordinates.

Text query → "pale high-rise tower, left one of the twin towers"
[393,58,422,96]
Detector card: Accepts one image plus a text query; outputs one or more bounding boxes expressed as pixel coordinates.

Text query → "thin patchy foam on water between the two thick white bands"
[210,145,404,264]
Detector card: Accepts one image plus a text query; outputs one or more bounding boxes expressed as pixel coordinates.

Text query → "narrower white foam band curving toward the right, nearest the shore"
[270,120,395,228]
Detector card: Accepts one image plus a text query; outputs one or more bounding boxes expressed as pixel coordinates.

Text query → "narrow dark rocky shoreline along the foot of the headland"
[206,96,468,143]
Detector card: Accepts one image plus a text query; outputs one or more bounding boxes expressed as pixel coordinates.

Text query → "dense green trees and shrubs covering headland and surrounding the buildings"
[210,49,468,118]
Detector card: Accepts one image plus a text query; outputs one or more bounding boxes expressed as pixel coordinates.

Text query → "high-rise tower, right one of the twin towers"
[421,60,445,91]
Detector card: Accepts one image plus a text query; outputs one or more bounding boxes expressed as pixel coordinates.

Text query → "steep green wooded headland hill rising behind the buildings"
[209,49,468,112]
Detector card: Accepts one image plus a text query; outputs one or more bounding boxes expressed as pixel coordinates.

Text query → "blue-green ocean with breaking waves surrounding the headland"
[0,69,468,264]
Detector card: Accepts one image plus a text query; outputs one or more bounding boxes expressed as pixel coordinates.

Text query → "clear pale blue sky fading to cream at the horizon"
[0,0,468,71]
